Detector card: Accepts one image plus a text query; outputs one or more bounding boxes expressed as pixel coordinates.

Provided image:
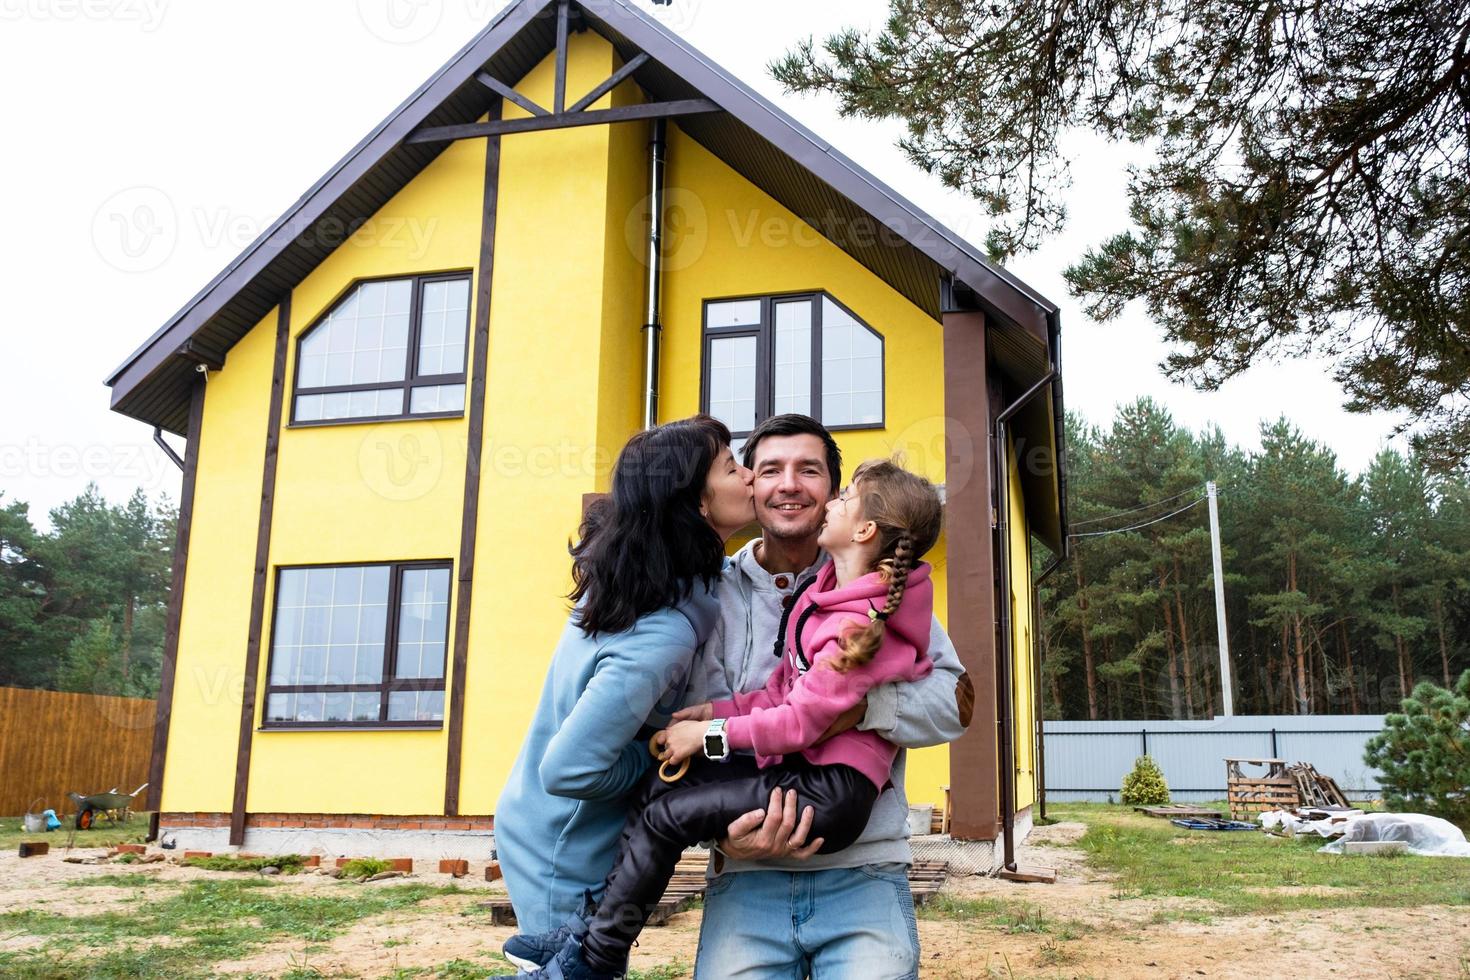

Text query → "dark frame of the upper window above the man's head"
[700,283,888,439]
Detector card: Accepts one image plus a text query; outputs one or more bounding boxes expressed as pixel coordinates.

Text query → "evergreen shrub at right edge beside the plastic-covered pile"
[1363,670,1470,827]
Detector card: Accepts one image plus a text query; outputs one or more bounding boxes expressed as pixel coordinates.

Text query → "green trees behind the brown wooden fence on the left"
[0,485,178,698]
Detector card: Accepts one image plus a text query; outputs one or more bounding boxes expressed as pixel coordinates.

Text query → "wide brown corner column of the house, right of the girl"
[944,310,1000,840]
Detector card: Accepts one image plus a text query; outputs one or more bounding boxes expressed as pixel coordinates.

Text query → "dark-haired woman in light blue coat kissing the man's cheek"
[495,416,756,965]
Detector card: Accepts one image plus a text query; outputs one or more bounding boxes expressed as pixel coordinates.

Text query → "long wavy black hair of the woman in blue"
[569,416,731,636]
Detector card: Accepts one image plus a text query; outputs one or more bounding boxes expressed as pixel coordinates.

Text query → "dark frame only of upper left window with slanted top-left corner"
[287,269,475,429]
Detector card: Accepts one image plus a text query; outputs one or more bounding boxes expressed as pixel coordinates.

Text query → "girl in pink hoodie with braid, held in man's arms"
[505,460,941,980]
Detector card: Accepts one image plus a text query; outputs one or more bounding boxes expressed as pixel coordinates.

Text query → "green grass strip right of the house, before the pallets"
[1050,804,1470,915]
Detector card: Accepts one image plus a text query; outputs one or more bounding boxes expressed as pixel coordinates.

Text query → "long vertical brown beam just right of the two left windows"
[444,107,500,817]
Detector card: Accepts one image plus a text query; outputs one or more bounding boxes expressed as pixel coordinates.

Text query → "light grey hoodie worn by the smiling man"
[688,539,964,871]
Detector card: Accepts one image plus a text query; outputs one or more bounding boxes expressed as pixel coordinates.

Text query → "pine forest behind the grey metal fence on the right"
[1036,398,1470,718]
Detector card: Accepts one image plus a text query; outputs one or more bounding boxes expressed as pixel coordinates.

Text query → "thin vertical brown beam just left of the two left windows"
[229,291,291,846]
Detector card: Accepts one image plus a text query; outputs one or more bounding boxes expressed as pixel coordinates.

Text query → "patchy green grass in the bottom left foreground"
[0,879,445,980]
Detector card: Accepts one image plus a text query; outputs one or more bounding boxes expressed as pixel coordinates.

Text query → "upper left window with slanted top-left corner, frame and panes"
[291,273,469,425]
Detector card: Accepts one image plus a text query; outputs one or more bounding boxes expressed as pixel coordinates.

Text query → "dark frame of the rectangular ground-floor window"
[257,558,454,732]
